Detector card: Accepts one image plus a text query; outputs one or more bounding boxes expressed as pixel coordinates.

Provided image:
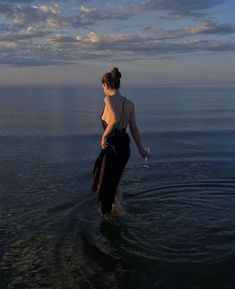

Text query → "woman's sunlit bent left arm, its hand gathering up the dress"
[101,96,117,149]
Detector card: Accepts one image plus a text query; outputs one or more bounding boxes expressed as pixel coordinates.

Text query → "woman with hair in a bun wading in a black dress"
[92,67,149,215]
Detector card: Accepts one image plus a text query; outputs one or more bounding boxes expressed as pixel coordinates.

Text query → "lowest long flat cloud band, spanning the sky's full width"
[0,29,235,66]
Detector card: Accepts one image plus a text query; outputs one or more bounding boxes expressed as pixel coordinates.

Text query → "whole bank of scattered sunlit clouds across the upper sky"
[0,0,235,66]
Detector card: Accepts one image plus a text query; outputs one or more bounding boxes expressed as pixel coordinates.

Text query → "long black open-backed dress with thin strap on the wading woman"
[92,98,130,214]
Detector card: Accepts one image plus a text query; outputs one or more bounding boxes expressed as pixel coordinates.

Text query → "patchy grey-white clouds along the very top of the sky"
[0,0,222,29]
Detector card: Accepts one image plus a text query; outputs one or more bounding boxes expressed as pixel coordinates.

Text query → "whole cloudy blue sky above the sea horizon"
[0,0,235,86]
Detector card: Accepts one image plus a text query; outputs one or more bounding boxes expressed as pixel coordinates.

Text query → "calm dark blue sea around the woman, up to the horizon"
[0,86,235,289]
